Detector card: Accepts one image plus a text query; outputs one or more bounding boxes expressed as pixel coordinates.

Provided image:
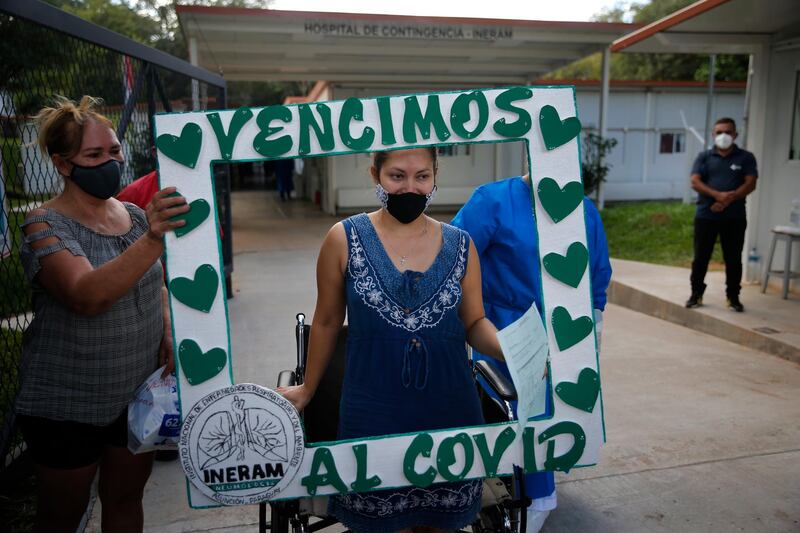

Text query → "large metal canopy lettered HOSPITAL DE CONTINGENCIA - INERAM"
[176,5,639,86]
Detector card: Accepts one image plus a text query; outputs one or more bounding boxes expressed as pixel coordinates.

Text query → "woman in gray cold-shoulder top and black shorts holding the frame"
[16,96,188,532]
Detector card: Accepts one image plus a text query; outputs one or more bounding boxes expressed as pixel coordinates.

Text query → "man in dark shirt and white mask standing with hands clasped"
[686,118,758,313]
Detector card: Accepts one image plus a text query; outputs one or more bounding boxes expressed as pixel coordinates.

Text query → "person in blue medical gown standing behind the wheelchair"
[451,175,611,532]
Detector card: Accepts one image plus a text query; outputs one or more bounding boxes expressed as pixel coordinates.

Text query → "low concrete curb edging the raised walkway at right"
[608,281,800,364]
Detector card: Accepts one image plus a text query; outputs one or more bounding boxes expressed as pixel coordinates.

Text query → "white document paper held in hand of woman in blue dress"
[497,304,549,425]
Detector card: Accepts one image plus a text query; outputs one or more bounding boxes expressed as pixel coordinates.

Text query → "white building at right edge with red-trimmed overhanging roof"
[611,0,800,290]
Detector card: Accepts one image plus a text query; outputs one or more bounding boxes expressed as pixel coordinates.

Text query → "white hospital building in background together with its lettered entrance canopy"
[177,6,744,213]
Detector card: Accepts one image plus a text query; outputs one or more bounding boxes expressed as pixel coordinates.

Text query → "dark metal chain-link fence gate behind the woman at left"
[0,0,232,476]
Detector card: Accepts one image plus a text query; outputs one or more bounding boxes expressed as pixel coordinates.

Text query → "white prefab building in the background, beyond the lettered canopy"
[302,81,745,213]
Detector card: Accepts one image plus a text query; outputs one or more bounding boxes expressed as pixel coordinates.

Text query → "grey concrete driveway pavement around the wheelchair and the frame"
[87,192,800,533]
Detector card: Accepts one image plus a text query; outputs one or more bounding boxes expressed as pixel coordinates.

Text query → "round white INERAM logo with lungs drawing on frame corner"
[179,383,305,505]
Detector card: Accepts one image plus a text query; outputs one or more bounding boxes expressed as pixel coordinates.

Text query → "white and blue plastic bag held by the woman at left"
[128,366,181,453]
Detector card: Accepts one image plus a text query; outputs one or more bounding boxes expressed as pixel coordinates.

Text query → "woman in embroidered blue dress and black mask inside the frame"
[281,148,502,533]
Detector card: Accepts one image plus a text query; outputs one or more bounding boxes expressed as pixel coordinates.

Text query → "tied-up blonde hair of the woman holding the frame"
[34,95,114,159]
